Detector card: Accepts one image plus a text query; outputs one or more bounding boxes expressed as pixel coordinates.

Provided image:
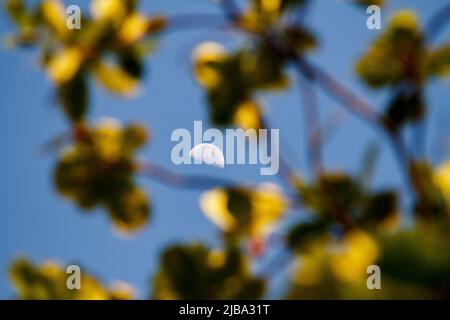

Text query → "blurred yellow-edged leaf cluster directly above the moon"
[194,42,288,129]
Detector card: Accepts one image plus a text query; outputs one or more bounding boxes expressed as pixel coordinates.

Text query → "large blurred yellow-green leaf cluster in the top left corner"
[5,0,166,122]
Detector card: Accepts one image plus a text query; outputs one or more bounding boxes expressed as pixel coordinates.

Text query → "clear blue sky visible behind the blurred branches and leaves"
[0,0,450,298]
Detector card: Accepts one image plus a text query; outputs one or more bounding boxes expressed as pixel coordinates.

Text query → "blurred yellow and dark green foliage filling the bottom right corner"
[287,221,450,299]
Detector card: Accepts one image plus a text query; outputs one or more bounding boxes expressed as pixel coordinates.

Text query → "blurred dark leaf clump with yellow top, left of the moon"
[54,119,150,232]
